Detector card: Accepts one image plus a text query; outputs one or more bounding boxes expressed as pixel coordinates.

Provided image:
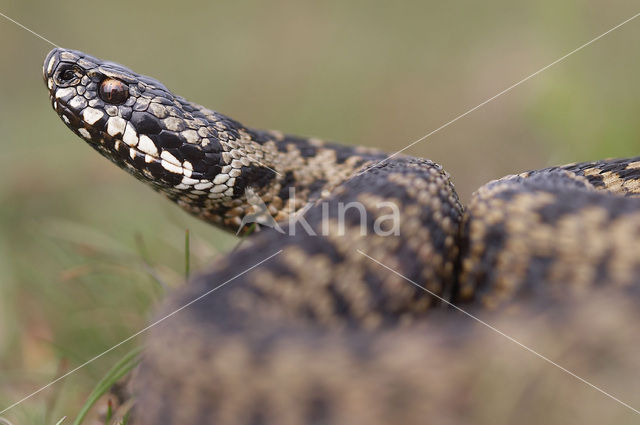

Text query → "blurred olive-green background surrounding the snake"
[0,0,640,424]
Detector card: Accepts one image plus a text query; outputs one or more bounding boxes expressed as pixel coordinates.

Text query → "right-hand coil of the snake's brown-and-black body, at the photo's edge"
[459,163,640,308]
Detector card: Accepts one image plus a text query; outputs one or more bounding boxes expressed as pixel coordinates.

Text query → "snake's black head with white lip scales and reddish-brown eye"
[43,48,262,207]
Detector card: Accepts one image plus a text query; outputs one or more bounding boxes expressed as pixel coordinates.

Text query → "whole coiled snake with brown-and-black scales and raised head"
[43,48,640,425]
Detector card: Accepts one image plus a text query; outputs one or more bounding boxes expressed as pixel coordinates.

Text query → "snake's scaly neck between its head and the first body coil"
[152,113,384,232]
